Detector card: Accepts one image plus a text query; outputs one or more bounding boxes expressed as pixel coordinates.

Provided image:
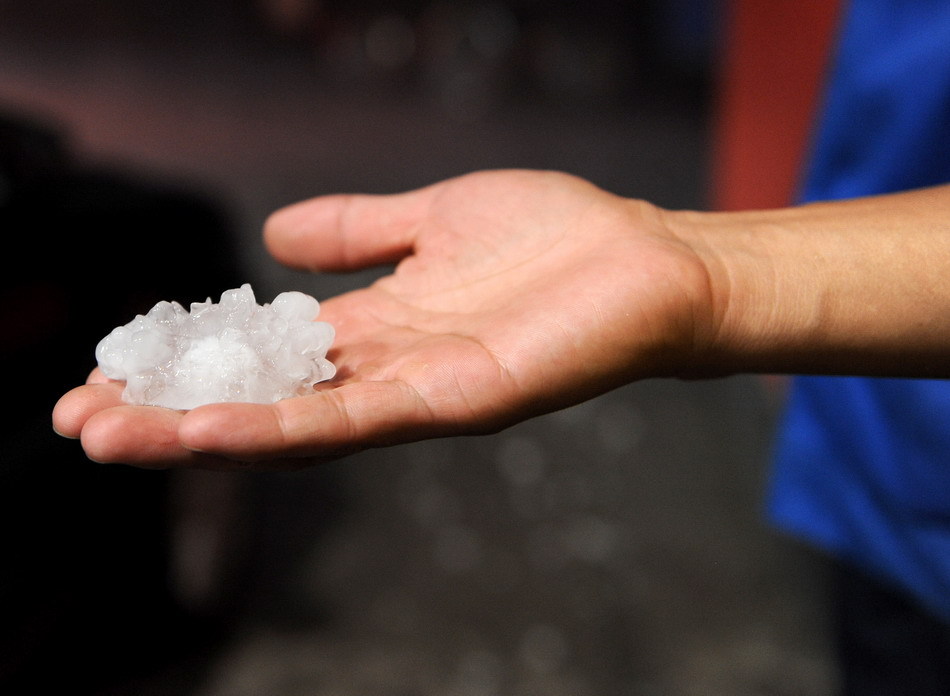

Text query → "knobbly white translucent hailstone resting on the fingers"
[96,284,336,409]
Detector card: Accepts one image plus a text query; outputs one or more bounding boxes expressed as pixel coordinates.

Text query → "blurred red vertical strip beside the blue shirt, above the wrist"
[711,0,842,210]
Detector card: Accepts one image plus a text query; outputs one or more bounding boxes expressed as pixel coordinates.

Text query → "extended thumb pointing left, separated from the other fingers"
[264,189,429,271]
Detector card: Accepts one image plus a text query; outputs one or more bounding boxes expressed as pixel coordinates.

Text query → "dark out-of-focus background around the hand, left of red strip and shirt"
[0,0,835,696]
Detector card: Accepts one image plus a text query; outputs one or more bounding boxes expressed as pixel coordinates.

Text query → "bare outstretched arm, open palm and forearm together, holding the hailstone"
[53,171,950,469]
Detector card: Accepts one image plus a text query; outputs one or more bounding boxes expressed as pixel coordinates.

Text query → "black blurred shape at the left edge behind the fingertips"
[0,115,240,694]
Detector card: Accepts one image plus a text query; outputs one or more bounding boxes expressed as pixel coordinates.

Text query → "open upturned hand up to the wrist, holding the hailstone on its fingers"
[54,171,711,468]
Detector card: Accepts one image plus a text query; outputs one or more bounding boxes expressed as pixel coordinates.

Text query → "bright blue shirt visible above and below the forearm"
[769,0,950,620]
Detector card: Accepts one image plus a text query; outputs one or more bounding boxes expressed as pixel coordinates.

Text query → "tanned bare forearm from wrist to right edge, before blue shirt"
[670,186,950,377]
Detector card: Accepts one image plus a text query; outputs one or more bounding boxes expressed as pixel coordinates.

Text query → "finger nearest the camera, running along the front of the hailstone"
[179,381,441,461]
